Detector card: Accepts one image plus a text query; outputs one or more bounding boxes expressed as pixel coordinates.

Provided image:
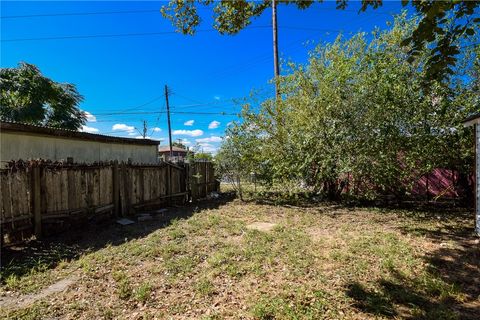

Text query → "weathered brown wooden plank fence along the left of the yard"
[0,162,218,245]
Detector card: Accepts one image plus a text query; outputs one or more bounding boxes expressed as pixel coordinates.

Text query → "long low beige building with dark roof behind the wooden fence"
[0,121,160,168]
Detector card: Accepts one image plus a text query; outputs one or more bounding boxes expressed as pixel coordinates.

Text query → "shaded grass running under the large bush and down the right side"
[240,192,480,320]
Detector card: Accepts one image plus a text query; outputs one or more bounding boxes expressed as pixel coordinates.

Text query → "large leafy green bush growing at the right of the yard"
[217,16,479,198]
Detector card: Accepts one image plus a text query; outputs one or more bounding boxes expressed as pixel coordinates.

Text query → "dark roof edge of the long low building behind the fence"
[0,120,160,146]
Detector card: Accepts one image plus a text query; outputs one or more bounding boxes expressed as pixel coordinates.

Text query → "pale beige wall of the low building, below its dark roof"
[0,132,158,167]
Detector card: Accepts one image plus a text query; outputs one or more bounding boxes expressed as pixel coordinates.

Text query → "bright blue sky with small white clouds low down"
[1,1,408,152]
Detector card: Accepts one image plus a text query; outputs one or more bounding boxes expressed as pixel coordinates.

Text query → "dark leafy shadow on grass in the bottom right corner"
[346,240,480,320]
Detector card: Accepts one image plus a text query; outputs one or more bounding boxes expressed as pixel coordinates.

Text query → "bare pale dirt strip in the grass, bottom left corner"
[0,276,78,309]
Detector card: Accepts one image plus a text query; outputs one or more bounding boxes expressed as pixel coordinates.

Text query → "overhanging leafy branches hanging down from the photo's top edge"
[161,0,480,82]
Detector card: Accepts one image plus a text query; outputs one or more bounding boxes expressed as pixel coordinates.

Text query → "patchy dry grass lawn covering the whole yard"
[0,196,480,319]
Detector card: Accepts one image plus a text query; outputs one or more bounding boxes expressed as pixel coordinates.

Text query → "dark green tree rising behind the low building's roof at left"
[0,62,86,130]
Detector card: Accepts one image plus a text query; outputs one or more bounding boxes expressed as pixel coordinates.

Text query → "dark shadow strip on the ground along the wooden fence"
[0,195,233,285]
